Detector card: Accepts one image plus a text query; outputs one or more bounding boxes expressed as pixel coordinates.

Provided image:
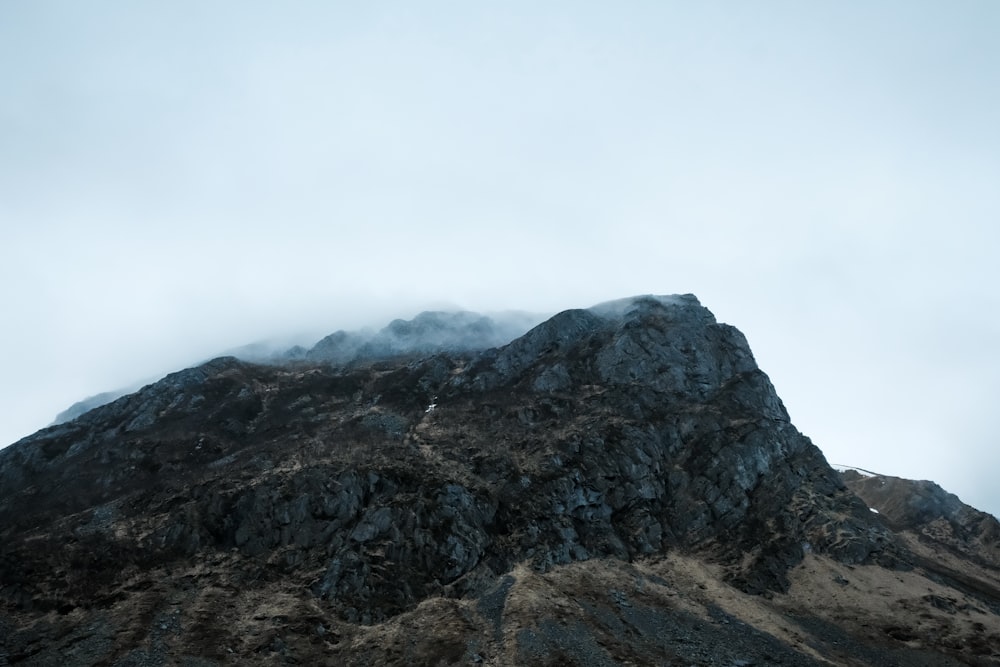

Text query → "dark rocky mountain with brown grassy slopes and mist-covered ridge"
[0,295,1000,667]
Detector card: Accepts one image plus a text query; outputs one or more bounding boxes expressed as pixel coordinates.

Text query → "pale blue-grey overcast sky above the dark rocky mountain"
[0,0,1000,514]
